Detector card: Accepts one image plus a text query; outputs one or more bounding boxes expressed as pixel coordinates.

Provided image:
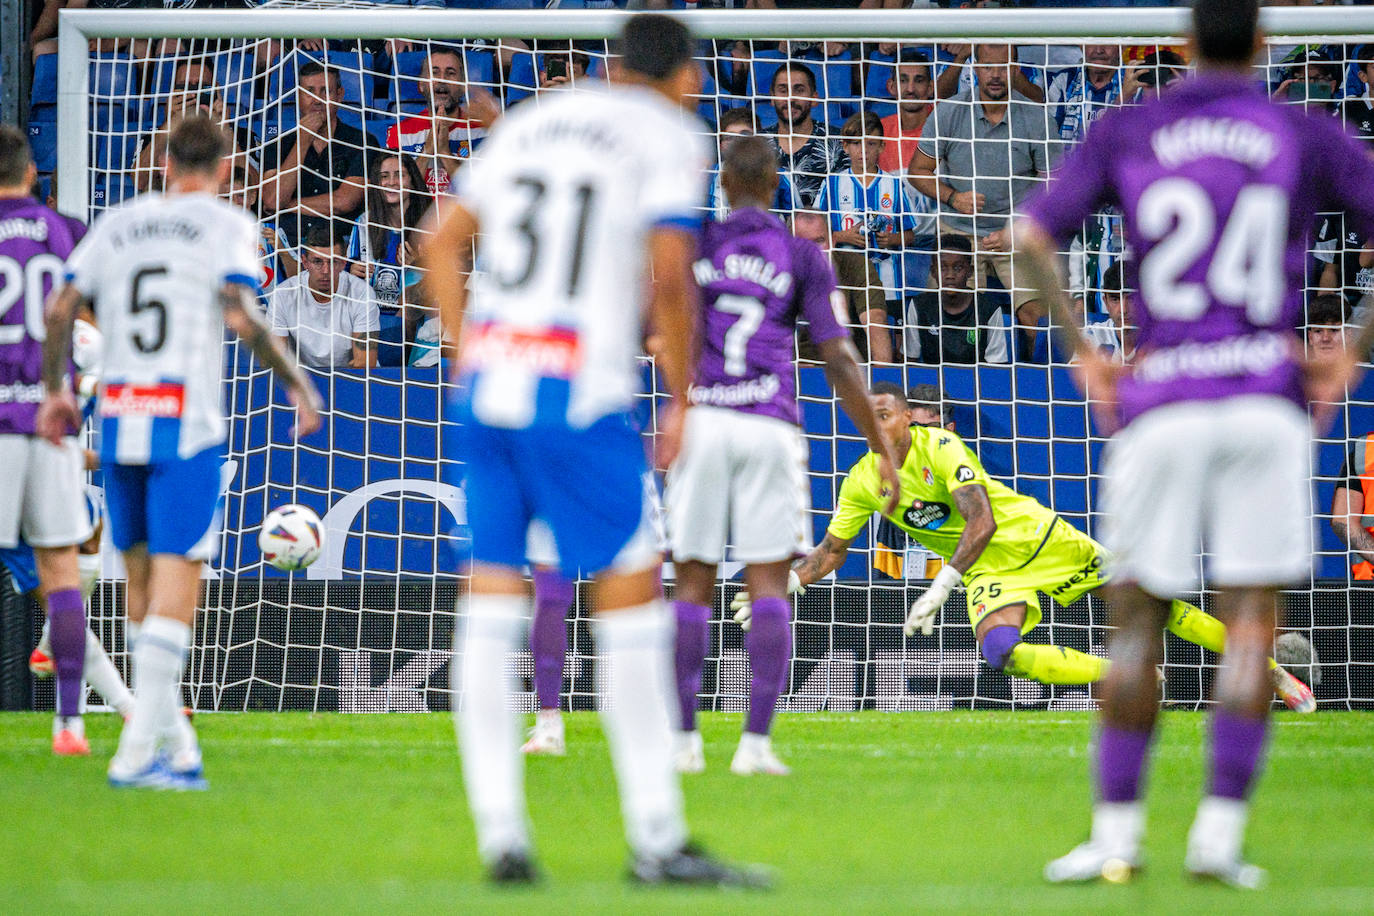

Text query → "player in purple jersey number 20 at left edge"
[0,125,91,755]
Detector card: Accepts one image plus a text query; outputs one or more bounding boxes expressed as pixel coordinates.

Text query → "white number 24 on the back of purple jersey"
[1136,177,1289,327]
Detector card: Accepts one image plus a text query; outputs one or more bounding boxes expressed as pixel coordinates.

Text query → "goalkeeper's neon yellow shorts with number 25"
[963,518,1110,633]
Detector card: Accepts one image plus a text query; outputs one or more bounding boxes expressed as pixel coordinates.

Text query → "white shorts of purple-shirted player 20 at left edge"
[0,434,92,548]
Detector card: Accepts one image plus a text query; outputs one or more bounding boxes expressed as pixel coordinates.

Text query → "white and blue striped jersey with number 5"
[67,194,260,464]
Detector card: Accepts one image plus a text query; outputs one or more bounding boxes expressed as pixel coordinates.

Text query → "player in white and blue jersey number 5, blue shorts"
[37,117,320,790]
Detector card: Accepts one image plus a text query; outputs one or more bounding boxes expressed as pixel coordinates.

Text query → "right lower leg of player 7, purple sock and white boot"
[730,560,791,776]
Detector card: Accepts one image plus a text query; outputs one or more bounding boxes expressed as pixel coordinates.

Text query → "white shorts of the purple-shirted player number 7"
[668,407,809,563]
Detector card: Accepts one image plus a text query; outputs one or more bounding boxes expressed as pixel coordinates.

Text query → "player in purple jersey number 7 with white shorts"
[666,137,899,773]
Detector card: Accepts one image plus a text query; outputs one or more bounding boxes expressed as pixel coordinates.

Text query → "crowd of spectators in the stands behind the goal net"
[21,0,1374,368]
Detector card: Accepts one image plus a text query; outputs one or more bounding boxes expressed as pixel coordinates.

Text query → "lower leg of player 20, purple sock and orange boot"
[33,545,91,755]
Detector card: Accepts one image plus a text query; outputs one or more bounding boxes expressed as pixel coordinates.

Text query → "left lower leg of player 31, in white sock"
[453,563,536,883]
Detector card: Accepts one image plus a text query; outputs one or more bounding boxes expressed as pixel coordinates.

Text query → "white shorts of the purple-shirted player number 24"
[1102,396,1312,597]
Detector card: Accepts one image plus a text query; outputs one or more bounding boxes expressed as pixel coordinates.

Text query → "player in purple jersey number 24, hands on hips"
[1017,0,1374,887]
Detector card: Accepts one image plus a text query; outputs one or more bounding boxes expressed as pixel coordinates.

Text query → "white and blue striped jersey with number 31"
[453,87,708,428]
